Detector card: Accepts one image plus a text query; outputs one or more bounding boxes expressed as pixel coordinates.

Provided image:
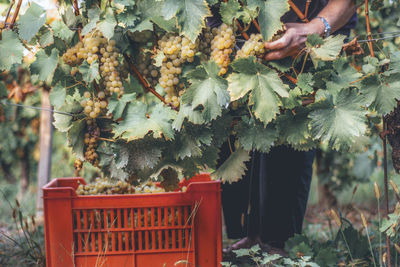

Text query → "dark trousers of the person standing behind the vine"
[222,146,315,247]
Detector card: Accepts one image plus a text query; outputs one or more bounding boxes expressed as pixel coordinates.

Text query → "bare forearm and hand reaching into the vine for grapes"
[264,0,356,60]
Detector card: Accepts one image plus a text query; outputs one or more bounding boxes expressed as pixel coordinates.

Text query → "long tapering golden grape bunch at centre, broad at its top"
[158,34,199,107]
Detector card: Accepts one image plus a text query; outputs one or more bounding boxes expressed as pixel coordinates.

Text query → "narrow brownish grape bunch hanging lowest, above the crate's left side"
[84,119,100,167]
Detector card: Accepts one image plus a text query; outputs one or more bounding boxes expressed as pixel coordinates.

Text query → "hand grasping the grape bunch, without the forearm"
[264,19,325,60]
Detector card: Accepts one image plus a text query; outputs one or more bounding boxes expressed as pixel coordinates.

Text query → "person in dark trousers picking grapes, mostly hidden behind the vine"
[221,0,357,253]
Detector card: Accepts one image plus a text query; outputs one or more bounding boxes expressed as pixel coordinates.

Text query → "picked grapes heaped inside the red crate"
[76,178,135,195]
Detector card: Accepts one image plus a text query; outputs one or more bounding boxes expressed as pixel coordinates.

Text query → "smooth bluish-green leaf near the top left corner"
[18,2,46,42]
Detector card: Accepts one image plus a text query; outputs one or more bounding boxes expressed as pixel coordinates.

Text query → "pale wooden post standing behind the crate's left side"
[36,87,53,217]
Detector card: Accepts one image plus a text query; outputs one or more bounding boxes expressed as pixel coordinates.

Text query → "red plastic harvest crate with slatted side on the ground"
[43,174,222,267]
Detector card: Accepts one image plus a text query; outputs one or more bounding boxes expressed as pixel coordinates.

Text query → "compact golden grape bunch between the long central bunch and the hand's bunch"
[211,23,235,75]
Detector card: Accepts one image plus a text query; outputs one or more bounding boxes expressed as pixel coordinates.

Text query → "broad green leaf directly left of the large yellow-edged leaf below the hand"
[182,61,229,121]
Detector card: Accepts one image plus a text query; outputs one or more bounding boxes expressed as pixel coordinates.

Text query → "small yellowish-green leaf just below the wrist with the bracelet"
[307,34,346,66]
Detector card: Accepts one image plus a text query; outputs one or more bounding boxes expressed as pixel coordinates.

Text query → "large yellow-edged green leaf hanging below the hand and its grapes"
[228,57,289,124]
